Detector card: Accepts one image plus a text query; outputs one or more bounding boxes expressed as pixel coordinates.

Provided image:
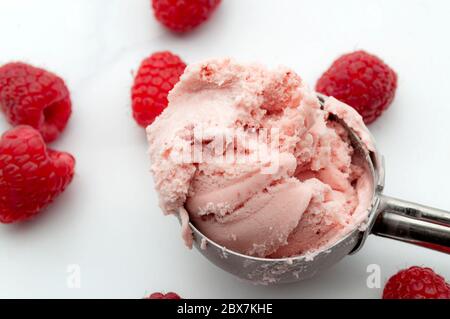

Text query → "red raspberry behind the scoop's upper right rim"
[316,51,397,124]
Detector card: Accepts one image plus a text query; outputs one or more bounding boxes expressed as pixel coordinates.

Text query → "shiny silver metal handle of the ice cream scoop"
[372,195,450,254]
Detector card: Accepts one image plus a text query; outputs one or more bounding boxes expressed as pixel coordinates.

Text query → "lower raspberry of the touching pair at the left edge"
[0,125,75,223]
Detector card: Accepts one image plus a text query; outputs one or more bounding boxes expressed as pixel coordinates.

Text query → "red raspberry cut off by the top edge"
[152,0,221,32]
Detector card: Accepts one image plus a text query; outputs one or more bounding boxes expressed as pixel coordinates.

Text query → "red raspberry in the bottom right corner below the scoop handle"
[383,266,450,299]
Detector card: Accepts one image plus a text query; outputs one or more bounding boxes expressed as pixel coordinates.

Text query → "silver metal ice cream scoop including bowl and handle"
[185,96,450,285]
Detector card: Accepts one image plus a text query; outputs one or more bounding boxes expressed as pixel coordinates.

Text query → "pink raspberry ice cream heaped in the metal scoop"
[147,59,373,258]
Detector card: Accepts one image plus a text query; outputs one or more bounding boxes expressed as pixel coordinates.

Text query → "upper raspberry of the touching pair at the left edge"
[0,62,72,142]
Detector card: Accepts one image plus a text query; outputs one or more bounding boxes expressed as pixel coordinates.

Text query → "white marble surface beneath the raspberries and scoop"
[0,0,450,298]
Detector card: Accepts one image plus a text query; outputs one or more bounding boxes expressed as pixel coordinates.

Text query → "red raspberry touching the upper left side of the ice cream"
[131,51,186,127]
